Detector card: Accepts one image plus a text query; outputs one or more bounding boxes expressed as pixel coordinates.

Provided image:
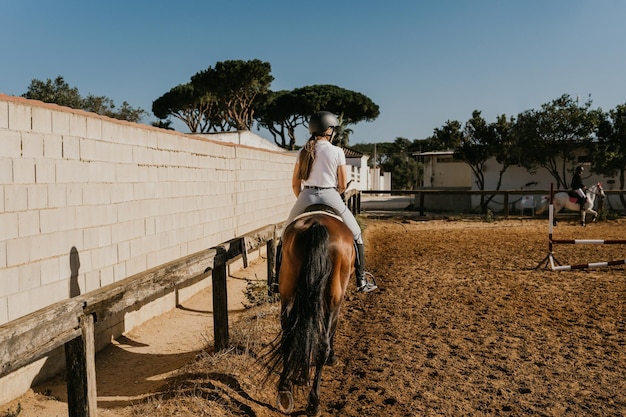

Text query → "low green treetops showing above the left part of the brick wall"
[22,76,146,123]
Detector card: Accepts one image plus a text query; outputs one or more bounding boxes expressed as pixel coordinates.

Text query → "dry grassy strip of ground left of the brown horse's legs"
[130,303,279,417]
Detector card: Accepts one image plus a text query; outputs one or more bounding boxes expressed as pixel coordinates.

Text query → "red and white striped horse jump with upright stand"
[537,184,626,271]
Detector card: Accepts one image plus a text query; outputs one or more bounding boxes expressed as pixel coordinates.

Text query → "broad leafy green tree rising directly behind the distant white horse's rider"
[515,94,600,188]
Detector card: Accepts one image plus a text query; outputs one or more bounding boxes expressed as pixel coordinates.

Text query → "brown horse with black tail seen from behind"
[272,211,356,416]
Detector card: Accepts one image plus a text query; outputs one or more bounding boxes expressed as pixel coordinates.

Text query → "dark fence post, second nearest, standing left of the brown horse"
[212,246,229,352]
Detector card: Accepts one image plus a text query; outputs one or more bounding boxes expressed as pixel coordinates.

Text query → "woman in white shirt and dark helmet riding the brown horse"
[285,111,378,293]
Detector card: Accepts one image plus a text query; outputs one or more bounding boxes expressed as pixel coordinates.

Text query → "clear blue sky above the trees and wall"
[0,0,626,144]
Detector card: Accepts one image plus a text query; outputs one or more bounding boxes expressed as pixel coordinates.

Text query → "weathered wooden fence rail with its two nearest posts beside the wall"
[0,225,278,417]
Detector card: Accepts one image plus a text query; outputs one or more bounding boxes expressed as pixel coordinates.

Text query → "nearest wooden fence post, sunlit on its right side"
[65,314,98,417]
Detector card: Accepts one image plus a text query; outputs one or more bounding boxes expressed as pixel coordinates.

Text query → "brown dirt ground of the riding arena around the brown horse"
[0,214,626,417]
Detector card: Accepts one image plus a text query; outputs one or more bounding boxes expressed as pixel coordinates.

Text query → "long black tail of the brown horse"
[280,219,333,385]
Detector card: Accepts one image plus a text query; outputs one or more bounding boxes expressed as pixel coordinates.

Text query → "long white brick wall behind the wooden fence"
[0,95,295,403]
